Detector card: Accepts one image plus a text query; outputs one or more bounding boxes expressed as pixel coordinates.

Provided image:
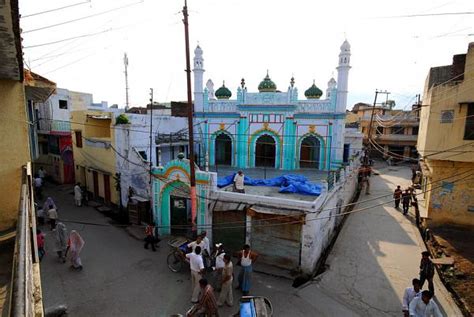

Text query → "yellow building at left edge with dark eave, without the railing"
[0,1,30,232]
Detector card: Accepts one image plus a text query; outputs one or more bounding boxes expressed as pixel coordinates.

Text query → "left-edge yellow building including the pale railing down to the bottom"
[0,0,43,316]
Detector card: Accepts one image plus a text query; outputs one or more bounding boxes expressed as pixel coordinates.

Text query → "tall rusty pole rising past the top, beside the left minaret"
[183,0,197,231]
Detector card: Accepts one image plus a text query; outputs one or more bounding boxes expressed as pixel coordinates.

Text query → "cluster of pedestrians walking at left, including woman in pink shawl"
[36,197,85,270]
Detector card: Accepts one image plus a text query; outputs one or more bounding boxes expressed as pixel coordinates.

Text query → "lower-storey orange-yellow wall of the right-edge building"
[422,160,474,226]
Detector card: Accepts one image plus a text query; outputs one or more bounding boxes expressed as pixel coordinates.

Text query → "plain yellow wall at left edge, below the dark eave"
[0,80,30,231]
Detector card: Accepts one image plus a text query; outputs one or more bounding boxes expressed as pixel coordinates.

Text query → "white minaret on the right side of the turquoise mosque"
[336,40,351,112]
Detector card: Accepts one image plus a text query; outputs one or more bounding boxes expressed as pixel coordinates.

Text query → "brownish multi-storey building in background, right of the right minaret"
[351,103,419,160]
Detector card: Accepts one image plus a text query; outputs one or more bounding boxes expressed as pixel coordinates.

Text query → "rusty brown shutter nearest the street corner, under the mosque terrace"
[249,209,302,270]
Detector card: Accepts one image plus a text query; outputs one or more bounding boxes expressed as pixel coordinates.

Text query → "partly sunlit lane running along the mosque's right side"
[298,165,462,316]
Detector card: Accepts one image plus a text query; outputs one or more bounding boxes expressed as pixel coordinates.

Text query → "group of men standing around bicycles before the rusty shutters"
[185,231,258,316]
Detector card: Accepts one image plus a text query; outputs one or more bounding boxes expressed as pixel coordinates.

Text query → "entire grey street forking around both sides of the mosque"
[41,167,458,316]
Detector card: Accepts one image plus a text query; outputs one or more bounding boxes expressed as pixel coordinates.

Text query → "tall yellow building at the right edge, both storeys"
[417,43,474,225]
